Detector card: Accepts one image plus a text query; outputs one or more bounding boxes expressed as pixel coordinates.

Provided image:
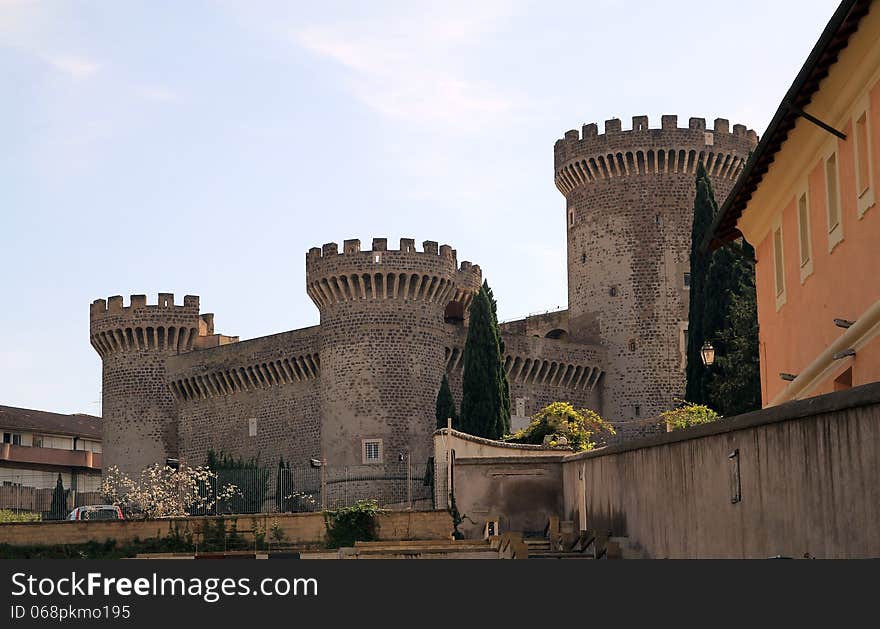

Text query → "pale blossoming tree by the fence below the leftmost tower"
[101,463,241,518]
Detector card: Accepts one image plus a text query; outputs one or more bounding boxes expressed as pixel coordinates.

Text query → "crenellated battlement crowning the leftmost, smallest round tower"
[89,293,205,358]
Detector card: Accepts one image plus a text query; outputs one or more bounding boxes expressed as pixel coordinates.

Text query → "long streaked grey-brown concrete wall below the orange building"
[563,383,880,558]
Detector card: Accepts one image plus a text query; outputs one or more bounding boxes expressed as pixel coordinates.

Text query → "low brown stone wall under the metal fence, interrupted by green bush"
[0,511,452,546]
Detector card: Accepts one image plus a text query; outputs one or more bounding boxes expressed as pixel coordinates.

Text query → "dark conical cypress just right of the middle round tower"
[460,287,510,439]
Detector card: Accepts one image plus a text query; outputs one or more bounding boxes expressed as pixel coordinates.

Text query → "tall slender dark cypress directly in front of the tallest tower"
[685,161,718,404]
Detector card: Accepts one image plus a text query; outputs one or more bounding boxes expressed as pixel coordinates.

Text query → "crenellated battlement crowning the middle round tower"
[306,238,482,309]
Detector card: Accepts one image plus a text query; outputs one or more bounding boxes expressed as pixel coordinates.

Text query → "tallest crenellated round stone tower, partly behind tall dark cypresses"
[554,116,757,420]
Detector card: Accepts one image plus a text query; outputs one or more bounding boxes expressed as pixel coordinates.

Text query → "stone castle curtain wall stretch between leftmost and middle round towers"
[168,326,321,467]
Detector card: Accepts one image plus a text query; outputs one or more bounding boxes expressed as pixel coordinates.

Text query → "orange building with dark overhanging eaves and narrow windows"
[713,1,880,406]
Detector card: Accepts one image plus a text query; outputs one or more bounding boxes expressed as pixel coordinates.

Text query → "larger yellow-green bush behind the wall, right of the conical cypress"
[508,402,616,451]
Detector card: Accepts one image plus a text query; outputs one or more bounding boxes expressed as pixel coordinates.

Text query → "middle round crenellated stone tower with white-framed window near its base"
[306,238,480,502]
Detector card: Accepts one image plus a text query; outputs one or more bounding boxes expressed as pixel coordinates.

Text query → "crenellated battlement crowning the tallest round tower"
[553,115,758,195]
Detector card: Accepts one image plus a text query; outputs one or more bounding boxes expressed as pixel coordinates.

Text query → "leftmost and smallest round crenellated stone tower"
[90,293,199,475]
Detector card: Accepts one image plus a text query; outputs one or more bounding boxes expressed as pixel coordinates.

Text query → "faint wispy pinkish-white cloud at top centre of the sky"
[293,3,515,130]
